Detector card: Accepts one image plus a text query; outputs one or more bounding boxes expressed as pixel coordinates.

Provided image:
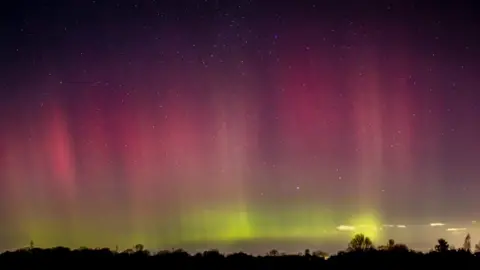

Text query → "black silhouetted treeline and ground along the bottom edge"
[0,235,480,270]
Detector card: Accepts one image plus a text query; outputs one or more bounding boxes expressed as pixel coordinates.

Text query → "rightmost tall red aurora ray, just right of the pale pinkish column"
[381,44,418,226]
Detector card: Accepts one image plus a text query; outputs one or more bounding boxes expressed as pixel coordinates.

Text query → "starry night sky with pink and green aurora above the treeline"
[0,0,480,252]
